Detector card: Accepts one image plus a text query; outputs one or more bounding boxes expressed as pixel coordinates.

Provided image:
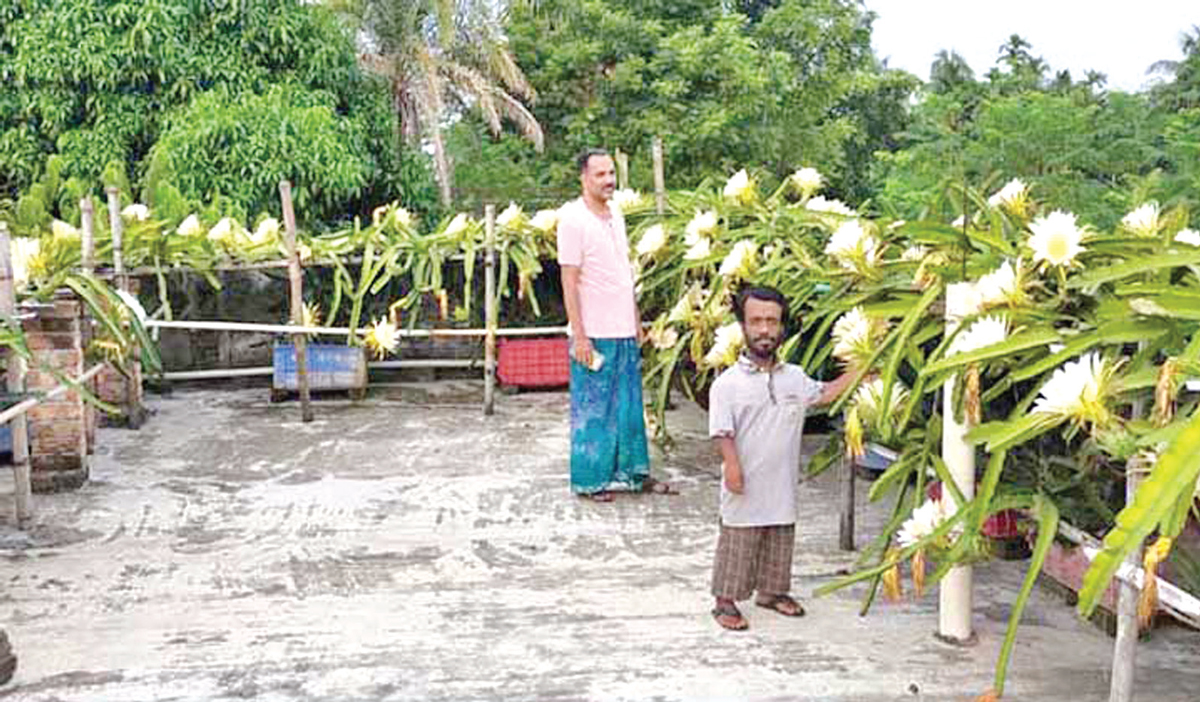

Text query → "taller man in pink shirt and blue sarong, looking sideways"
[558,149,670,502]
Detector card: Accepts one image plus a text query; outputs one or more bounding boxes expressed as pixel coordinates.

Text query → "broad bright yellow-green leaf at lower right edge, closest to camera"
[1078,412,1200,617]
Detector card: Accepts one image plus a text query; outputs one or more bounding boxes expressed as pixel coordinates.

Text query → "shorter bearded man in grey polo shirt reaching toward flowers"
[708,288,852,630]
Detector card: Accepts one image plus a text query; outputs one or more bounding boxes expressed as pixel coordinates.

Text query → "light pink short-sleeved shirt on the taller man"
[558,198,637,338]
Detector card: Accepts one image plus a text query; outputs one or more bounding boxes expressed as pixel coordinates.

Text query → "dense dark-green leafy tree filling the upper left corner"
[0,0,427,224]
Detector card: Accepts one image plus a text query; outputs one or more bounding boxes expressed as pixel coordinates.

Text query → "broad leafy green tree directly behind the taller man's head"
[509,0,911,196]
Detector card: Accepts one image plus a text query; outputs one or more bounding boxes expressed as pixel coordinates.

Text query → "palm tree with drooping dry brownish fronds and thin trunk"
[326,0,542,206]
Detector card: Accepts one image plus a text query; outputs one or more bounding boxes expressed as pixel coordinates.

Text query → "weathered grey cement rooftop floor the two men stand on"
[0,382,1200,702]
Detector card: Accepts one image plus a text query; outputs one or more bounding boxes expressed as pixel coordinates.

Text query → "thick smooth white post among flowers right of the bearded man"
[937,286,974,646]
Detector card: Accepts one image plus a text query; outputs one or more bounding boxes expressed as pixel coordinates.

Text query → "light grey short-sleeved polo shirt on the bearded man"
[708,356,824,527]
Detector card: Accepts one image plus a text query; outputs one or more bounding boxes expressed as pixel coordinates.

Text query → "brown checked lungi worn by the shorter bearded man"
[713,524,796,600]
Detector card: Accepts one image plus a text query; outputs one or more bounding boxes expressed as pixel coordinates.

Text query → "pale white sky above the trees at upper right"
[865,0,1200,91]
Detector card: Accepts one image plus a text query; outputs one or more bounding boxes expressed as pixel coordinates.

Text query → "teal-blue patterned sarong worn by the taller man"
[571,338,650,494]
